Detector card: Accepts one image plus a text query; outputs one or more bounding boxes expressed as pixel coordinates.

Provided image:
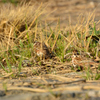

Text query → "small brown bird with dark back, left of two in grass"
[33,41,52,59]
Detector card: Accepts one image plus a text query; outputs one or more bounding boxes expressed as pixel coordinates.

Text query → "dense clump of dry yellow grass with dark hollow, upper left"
[0,3,43,51]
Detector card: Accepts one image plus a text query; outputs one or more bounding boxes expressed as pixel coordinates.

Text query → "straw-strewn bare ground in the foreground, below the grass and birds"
[0,63,100,100]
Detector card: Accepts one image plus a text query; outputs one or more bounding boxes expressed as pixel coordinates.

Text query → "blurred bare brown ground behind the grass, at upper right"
[26,0,100,28]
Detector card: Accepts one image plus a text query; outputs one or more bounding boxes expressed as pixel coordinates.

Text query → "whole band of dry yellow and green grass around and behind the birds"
[0,3,100,79]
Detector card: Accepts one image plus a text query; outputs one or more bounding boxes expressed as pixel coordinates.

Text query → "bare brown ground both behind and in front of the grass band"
[0,0,100,100]
